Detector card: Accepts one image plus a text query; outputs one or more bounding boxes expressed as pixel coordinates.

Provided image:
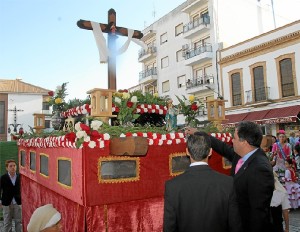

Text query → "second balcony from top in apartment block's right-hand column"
[184,44,213,66]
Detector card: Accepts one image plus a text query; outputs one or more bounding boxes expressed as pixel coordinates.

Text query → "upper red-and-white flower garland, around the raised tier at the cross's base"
[60,104,167,118]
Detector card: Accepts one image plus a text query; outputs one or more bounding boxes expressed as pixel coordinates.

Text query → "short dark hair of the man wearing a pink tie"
[236,121,263,147]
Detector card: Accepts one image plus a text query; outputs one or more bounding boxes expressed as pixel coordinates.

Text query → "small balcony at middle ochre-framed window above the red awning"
[245,87,272,105]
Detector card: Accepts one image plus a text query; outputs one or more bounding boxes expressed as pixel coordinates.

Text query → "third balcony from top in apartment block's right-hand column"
[186,75,214,94]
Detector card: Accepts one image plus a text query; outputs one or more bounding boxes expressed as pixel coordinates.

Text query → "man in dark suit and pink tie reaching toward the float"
[186,121,274,232]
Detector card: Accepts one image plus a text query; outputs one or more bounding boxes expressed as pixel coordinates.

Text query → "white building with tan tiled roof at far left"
[0,79,50,141]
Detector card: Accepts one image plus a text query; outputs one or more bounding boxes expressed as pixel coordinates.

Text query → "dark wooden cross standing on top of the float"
[77,9,143,90]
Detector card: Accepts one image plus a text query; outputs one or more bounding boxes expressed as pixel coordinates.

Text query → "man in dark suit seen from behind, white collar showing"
[163,132,242,232]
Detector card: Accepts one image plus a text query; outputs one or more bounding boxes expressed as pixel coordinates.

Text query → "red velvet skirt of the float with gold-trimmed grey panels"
[19,133,230,232]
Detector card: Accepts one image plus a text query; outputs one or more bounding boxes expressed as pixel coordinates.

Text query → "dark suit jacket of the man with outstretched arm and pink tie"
[211,137,274,232]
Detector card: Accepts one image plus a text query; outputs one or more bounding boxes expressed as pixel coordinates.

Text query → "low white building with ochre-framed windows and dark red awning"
[219,21,300,135]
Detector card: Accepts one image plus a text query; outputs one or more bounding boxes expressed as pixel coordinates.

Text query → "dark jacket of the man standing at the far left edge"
[0,173,21,206]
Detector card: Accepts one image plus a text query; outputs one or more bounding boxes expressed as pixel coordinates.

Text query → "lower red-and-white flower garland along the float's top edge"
[18,120,232,148]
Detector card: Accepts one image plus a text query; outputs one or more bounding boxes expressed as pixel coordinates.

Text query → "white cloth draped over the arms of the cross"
[91,21,147,63]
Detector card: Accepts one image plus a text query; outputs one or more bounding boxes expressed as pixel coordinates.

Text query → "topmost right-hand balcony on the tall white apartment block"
[183,15,210,39]
